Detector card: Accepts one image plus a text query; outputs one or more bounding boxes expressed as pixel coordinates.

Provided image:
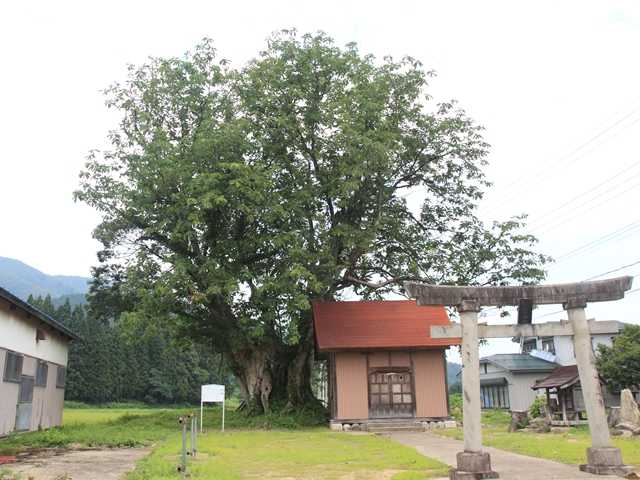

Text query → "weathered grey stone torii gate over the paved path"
[404,276,633,480]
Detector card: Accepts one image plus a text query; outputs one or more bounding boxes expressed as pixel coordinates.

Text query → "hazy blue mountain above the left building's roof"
[0,257,90,303]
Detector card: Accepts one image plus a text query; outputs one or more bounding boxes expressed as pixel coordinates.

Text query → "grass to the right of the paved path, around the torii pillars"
[435,410,640,467]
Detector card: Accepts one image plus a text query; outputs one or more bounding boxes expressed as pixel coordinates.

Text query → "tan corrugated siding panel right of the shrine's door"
[412,350,449,417]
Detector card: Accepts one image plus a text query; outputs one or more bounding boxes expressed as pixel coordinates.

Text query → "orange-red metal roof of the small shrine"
[313,300,460,352]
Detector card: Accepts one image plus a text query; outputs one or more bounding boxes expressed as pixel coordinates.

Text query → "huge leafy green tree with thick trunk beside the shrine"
[77,31,546,410]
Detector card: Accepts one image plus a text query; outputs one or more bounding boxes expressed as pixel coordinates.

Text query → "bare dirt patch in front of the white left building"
[5,448,151,480]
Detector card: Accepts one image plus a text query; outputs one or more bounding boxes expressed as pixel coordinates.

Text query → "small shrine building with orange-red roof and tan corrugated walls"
[313,301,460,426]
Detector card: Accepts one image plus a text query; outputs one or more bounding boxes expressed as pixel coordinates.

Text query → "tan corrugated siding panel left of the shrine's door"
[335,352,369,420]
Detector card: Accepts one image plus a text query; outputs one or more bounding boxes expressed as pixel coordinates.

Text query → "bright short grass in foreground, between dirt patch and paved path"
[128,428,448,480]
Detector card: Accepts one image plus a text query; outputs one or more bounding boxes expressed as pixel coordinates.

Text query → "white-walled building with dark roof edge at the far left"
[0,288,77,436]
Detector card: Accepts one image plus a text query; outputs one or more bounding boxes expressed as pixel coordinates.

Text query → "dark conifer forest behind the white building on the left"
[28,296,233,404]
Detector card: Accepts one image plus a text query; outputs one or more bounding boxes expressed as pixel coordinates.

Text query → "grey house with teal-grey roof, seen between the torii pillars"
[480,353,558,410]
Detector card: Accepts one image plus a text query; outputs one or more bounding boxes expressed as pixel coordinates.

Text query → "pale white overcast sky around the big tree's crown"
[0,0,640,360]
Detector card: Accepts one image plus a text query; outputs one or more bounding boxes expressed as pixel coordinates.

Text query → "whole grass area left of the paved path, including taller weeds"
[0,406,448,480]
